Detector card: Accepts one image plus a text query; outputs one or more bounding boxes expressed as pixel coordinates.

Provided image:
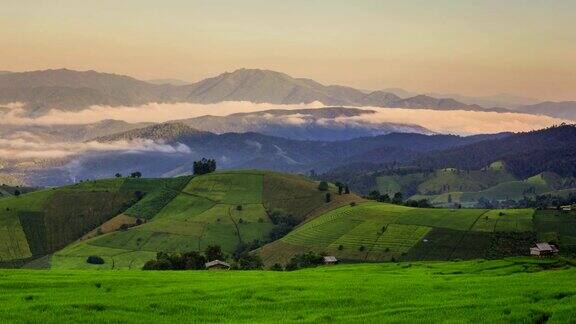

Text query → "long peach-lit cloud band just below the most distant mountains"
[0,102,569,135]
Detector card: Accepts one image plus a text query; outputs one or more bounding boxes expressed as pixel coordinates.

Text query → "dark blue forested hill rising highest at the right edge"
[411,125,576,178]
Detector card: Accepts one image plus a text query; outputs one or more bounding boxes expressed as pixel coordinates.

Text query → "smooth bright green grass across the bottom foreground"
[0,259,576,323]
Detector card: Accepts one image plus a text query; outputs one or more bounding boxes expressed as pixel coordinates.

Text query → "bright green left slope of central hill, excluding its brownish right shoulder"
[51,174,273,268]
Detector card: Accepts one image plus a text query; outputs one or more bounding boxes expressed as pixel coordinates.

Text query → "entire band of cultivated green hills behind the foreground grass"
[0,170,576,269]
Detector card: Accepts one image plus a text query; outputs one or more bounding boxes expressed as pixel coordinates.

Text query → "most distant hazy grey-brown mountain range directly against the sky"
[0,69,503,115]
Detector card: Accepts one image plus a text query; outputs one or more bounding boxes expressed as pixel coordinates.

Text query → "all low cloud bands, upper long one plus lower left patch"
[0,102,569,159]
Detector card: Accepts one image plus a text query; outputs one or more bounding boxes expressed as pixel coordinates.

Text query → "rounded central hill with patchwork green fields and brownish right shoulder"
[49,171,361,269]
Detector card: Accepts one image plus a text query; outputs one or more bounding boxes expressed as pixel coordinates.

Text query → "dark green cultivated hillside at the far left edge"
[0,178,190,266]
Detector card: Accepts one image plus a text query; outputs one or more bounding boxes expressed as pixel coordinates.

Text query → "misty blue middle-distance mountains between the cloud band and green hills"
[9,122,502,186]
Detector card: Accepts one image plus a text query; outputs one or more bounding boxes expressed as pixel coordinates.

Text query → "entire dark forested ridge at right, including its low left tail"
[323,125,576,196]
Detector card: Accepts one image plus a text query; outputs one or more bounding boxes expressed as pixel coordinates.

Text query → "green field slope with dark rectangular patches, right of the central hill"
[259,202,535,265]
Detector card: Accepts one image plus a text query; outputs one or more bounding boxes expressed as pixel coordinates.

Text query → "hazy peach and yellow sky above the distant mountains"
[0,0,576,100]
